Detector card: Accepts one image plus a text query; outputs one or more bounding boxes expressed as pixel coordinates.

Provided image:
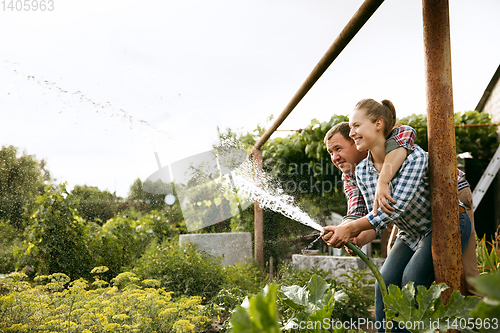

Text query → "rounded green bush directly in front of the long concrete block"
[133,238,224,301]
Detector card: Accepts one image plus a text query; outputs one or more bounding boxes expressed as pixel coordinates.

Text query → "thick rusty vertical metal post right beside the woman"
[422,0,464,303]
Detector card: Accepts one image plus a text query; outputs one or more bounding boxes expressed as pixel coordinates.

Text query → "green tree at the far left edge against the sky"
[0,146,50,231]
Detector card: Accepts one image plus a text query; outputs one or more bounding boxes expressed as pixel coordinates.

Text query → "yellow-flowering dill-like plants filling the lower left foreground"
[0,273,211,333]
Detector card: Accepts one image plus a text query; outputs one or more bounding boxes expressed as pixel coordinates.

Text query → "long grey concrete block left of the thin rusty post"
[179,232,253,265]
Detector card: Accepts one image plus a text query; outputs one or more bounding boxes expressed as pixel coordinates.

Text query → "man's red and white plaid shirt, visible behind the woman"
[342,125,416,219]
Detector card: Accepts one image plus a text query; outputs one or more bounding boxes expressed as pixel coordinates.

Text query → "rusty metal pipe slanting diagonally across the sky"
[251,0,384,154]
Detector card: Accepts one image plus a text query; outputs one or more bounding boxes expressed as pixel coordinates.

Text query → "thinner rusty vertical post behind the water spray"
[253,150,264,269]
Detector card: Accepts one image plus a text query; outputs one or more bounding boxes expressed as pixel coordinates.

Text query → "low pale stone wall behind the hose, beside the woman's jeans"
[292,254,384,282]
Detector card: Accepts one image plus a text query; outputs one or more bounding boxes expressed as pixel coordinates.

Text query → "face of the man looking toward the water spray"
[326,133,367,173]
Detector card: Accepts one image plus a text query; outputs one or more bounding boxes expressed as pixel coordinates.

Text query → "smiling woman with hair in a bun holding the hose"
[325,99,470,331]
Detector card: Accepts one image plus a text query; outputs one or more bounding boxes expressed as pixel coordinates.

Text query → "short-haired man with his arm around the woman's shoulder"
[324,122,479,296]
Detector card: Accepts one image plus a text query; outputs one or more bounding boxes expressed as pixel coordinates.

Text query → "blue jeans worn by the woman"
[375,213,471,332]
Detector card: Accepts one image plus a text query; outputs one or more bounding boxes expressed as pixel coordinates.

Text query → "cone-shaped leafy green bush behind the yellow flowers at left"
[18,184,92,279]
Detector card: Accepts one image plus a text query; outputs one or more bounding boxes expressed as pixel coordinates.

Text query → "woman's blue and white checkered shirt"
[356,146,432,250]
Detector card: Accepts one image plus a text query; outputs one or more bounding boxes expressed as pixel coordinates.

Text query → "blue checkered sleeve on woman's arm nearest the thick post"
[366,149,430,230]
